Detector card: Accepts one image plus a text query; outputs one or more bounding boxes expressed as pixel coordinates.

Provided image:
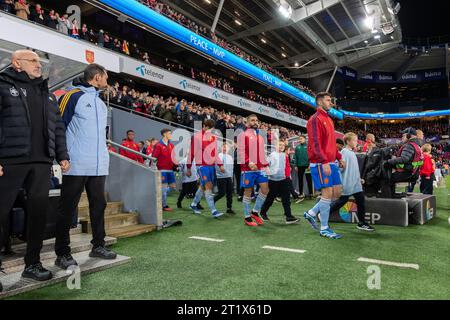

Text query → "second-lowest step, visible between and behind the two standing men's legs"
[1,233,117,269]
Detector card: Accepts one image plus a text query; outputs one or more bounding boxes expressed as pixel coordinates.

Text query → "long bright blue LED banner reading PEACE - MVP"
[99,0,343,119]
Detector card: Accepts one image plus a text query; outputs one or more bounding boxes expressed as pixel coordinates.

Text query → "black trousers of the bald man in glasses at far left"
[0,163,51,267]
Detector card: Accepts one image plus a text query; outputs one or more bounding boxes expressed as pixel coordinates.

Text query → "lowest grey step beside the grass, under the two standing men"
[0,251,131,299]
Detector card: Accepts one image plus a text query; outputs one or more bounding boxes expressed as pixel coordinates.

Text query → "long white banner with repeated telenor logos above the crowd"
[120,57,306,127]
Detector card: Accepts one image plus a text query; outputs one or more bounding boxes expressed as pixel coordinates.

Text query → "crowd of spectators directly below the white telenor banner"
[104,82,300,138]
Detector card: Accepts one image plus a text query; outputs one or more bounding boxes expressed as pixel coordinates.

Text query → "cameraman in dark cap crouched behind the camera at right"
[384,128,423,195]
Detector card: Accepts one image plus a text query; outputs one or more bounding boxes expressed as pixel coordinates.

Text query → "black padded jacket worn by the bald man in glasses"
[0,68,69,164]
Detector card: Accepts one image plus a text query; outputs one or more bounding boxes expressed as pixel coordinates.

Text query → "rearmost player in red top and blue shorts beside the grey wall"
[152,129,176,212]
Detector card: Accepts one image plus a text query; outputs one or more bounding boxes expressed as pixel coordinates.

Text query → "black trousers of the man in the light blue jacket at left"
[55,176,106,256]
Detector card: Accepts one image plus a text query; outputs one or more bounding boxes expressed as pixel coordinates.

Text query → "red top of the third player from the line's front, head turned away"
[187,130,223,169]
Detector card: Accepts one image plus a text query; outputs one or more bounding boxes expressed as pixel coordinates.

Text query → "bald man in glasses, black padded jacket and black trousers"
[0,50,70,288]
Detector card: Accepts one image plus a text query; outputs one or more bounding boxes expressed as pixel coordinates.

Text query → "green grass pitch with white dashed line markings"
[7,179,450,299]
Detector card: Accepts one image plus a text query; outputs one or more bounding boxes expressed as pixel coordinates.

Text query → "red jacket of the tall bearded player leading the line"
[306,108,342,164]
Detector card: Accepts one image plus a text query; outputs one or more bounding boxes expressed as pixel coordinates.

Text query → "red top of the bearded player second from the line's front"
[238,128,269,172]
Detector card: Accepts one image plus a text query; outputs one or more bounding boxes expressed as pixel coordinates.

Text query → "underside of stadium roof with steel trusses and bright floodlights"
[163,0,402,78]
